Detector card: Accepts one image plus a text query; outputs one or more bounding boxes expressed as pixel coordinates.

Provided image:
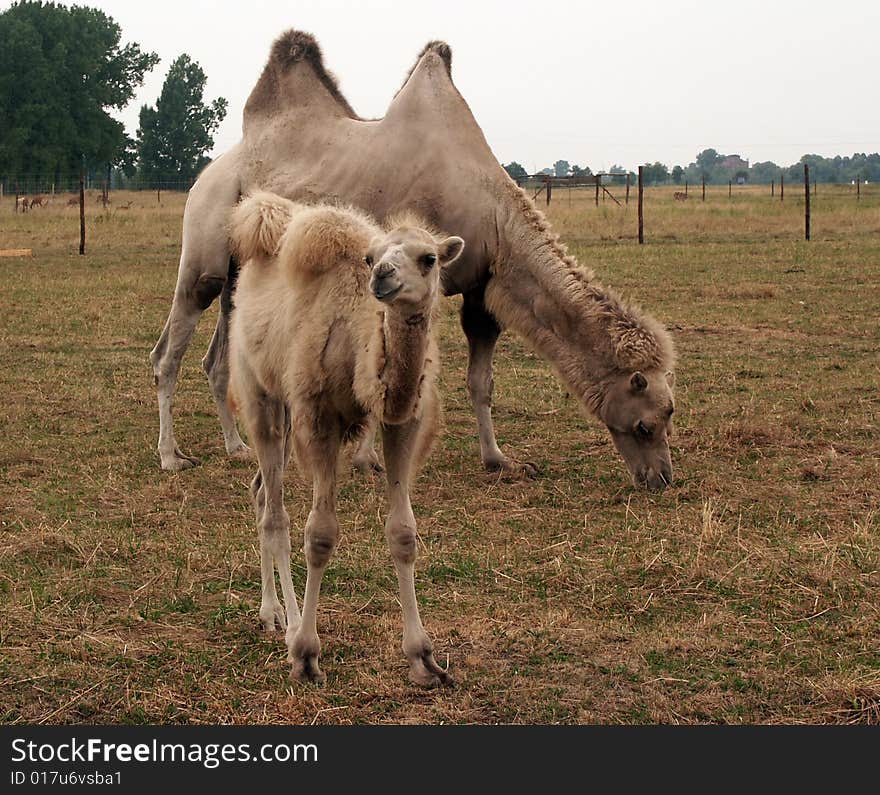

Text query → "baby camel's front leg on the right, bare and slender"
[382,420,453,687]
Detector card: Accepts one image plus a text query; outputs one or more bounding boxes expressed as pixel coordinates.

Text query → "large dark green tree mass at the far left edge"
[0,0,159,182]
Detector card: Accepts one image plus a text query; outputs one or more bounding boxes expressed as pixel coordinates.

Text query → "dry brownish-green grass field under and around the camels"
[0,185,880,724]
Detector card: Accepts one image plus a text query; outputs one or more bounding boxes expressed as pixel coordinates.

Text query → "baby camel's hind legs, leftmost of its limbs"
[248,393,300,632]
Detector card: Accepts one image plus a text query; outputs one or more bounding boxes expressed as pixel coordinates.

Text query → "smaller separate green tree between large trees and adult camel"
[137,53,227,187]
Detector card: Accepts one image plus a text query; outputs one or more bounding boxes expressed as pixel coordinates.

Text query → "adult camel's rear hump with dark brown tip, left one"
[244,30,358,125]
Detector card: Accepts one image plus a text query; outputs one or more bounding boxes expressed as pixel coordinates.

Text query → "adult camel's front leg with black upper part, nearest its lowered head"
[461,291,538,477]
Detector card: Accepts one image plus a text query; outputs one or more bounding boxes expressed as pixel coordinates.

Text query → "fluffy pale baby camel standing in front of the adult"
[230,193,464,685]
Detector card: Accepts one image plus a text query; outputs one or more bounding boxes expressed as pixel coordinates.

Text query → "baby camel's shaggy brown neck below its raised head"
[382,310,431,424]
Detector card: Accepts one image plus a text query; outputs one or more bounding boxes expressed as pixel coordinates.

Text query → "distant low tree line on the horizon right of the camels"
[504,149,880,185]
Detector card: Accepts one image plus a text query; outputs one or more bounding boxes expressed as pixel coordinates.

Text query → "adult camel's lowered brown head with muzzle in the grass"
[599,370,675,491]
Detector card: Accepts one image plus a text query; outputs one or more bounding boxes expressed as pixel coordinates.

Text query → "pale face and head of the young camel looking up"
[364,227,464,312]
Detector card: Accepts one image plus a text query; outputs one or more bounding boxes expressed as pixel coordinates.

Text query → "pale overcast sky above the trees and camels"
[8,0,880,172]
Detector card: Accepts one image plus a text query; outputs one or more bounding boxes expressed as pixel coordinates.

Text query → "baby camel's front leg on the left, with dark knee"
[287,418,342,684]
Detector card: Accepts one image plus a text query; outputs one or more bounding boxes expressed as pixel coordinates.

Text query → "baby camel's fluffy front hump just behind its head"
[278,204,382,283]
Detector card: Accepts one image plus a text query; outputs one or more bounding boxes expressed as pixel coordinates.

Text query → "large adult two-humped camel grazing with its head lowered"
[150,31,674,489]
